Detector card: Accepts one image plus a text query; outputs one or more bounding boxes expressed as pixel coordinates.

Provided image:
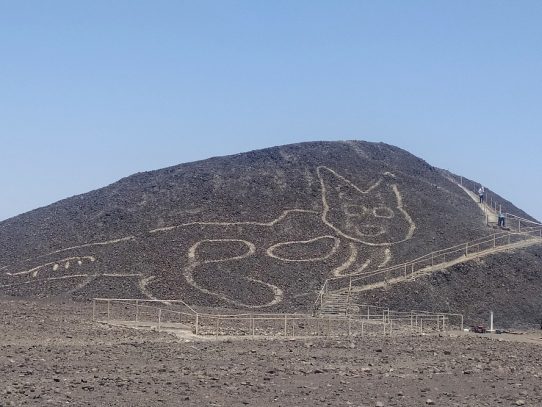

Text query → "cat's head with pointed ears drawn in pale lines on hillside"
[317,167,416,246]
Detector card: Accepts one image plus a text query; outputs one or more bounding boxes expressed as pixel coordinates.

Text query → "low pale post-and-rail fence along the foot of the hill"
[92,298,463,338]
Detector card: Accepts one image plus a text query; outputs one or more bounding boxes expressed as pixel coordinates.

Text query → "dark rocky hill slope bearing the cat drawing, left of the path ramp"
[0,141,541,324]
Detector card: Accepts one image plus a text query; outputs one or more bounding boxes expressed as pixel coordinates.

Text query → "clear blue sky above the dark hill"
[0,0,542,223]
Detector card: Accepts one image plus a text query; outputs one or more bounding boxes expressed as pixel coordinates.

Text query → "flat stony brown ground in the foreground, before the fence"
[0,299,542,407]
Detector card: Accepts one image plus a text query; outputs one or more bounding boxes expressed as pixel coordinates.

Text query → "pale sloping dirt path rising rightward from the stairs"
[348,238,542,292]
